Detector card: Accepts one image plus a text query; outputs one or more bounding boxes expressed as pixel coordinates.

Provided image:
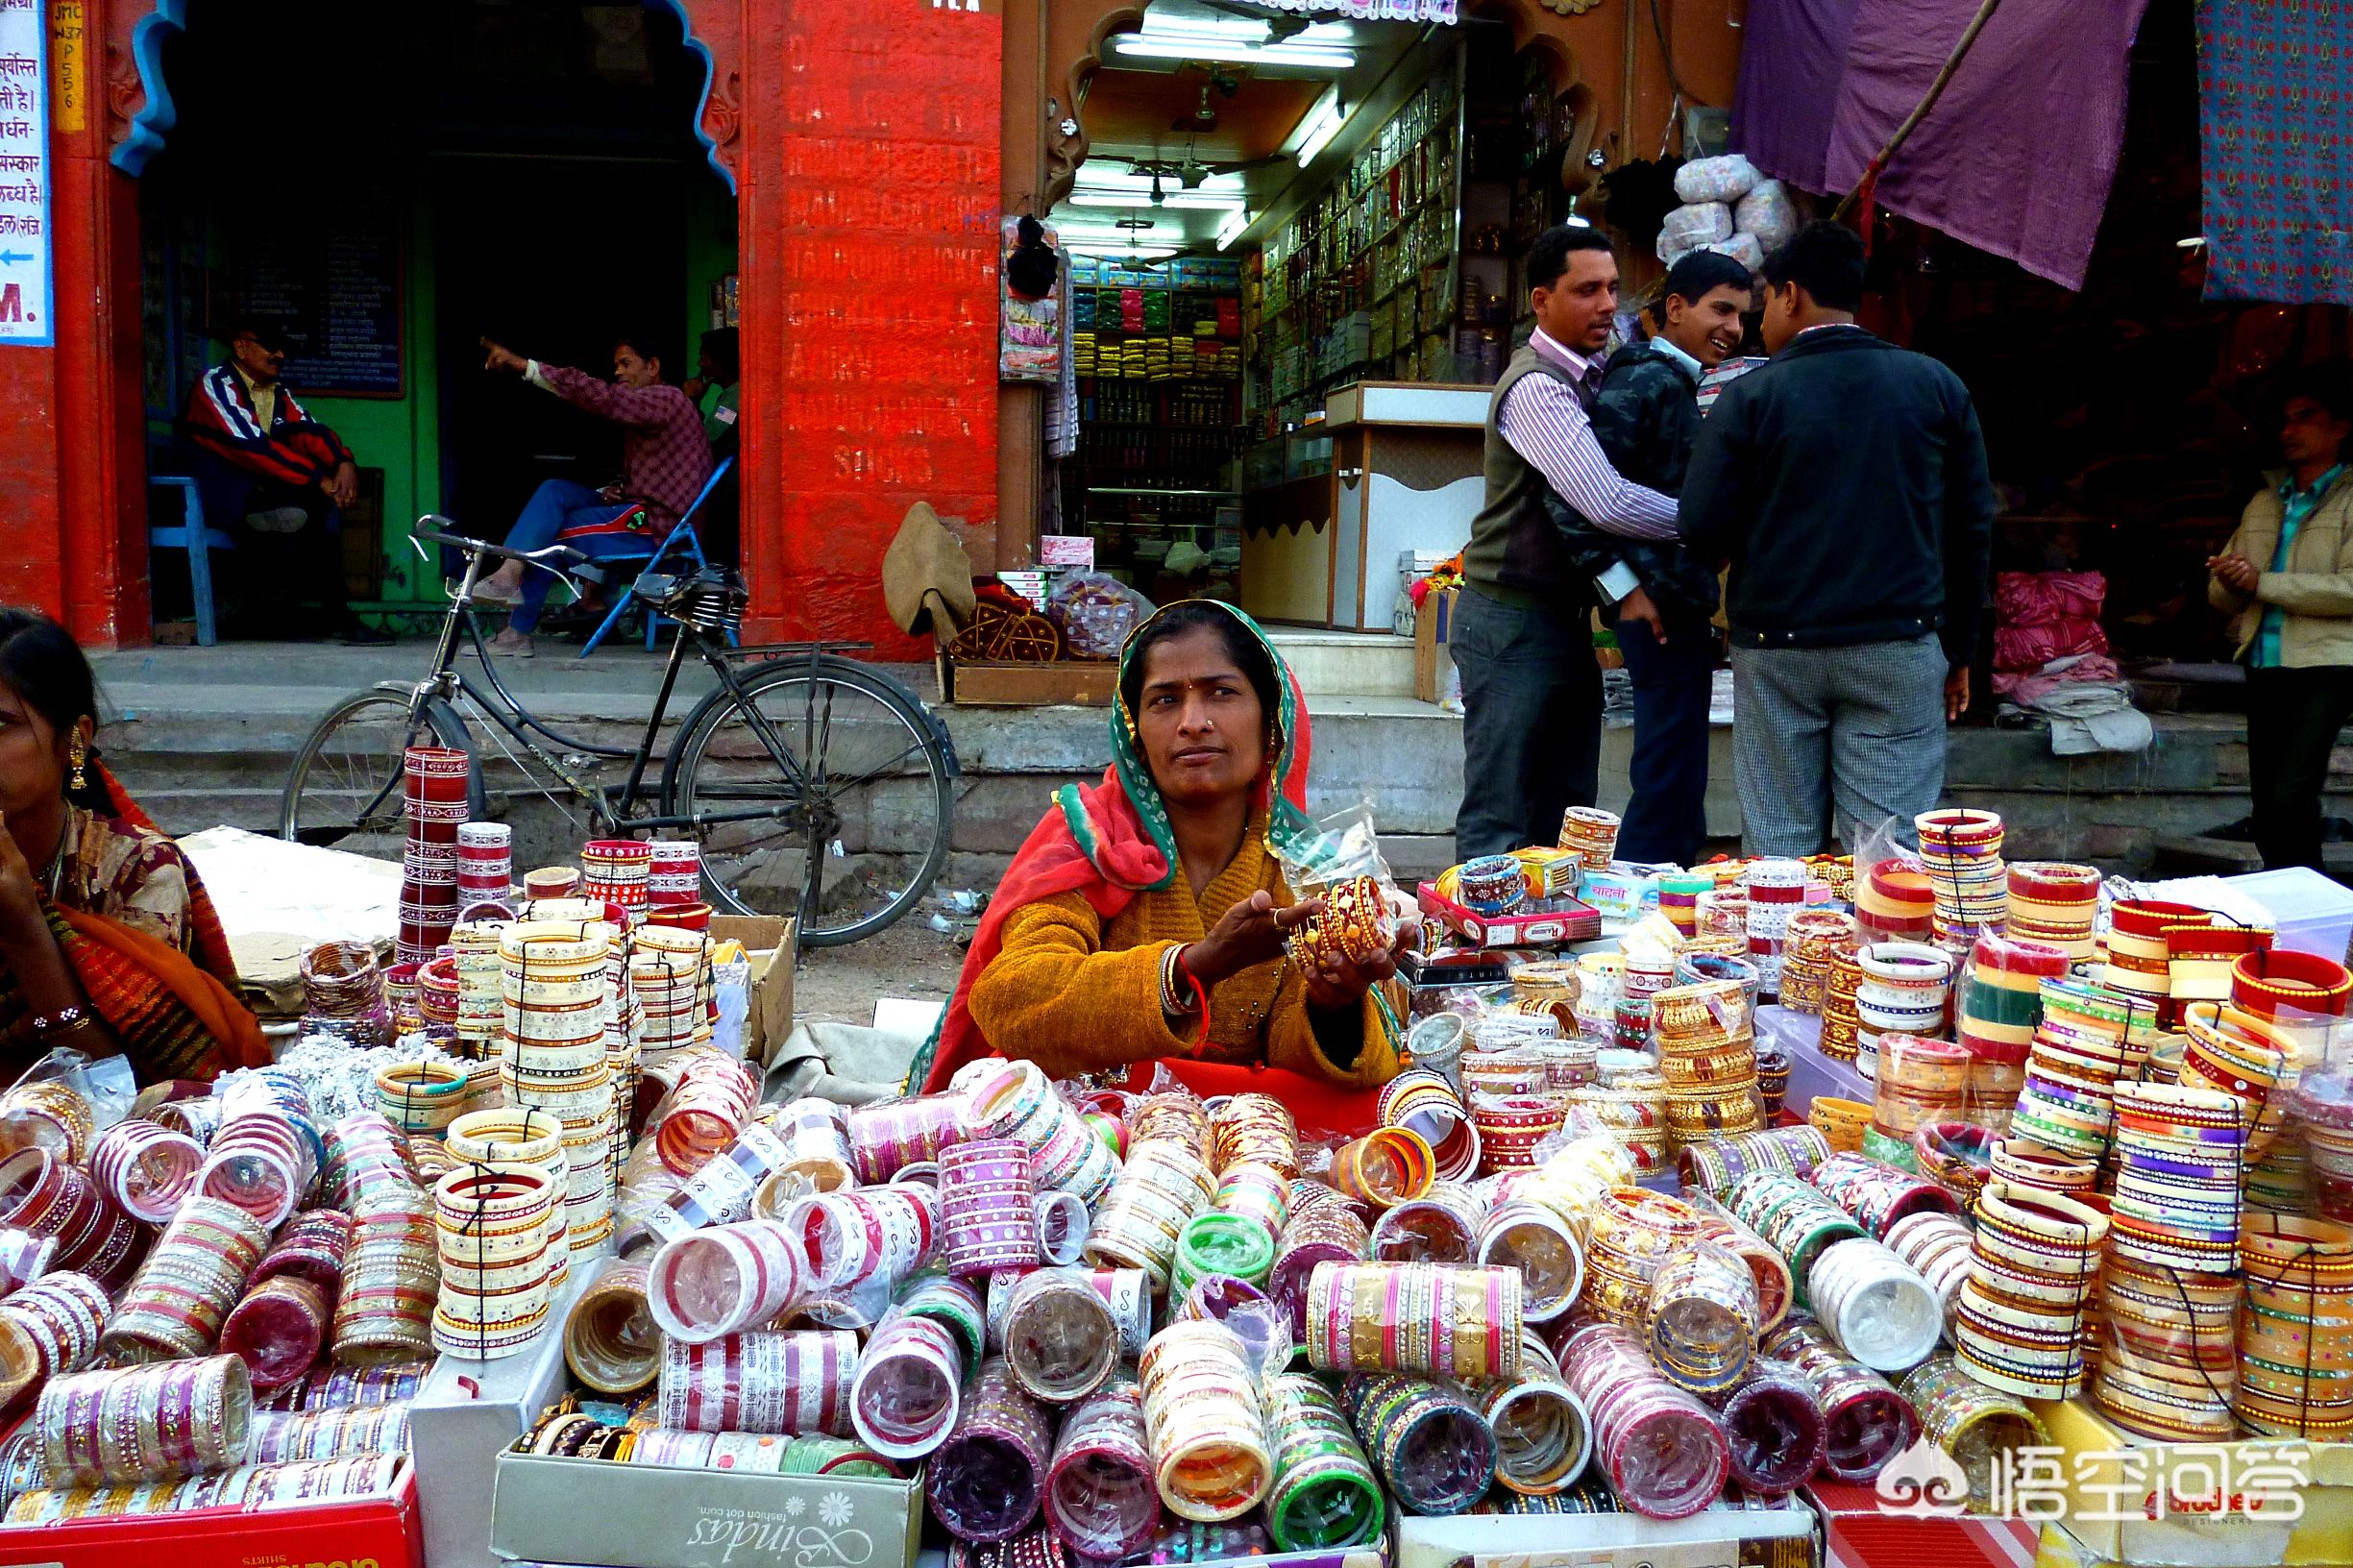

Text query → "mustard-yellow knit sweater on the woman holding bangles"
[968,812,1398,1088]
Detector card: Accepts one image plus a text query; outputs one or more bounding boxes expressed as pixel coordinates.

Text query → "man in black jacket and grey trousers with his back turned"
[1682,224,1996,855]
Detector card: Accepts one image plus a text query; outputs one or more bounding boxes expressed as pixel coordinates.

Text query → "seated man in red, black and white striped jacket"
[182,323,393,643]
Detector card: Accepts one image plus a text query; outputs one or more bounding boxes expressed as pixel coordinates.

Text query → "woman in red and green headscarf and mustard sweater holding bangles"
[913,600,1398,1125]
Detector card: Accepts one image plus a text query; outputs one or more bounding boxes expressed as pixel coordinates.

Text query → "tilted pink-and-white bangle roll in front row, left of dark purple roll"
[1560,1323,1731,1519]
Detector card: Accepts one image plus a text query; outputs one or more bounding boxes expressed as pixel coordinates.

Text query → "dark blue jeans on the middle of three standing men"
[1616,610,1715,867]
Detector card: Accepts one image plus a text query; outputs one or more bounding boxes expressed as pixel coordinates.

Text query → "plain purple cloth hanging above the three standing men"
[1731,0,2148,289]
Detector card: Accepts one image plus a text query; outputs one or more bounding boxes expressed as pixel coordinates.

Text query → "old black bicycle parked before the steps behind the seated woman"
[278,516,958,946]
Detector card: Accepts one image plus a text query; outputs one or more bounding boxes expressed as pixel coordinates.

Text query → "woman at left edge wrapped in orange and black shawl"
[0,610,268,1086]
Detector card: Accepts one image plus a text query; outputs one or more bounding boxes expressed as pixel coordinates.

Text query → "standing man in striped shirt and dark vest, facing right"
[1450,226,1676,859]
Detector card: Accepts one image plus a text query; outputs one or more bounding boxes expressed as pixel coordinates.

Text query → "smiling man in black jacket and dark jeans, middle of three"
[1546,250,1753,867]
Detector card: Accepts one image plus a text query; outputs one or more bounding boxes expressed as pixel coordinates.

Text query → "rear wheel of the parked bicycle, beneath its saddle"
[661,657,955,946]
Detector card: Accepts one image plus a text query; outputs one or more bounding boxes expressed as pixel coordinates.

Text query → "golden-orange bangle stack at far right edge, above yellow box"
[2236,1214,2353,1443]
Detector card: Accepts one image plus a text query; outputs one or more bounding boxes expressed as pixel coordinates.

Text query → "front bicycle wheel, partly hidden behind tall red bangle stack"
[278,688,482,859]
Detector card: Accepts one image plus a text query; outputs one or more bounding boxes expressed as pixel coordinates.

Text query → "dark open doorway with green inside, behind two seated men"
[138,0,737,638]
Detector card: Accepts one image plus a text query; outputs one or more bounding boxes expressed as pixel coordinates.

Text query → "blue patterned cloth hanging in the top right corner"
[2197,0,2353,304]
